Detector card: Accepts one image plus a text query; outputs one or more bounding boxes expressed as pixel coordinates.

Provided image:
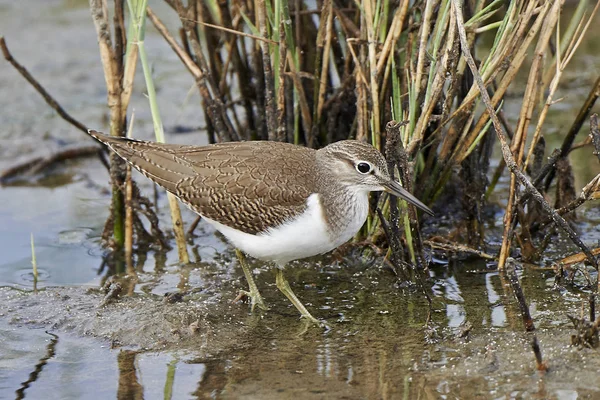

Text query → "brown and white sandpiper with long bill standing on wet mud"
[88,130,433,324]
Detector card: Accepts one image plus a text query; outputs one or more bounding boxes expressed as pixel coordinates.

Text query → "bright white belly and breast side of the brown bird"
[203,193,369,267]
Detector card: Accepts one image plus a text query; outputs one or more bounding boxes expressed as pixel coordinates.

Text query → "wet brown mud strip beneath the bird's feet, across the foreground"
[0,264,600,398]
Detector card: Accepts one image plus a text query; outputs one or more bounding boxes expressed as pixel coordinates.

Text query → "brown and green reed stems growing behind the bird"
[1,0,600,286]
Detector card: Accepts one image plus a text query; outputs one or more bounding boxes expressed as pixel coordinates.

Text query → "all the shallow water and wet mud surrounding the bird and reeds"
[0,0,600,399]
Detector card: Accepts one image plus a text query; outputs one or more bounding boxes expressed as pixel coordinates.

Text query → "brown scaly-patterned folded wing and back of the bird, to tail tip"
[90,131,315,234]
